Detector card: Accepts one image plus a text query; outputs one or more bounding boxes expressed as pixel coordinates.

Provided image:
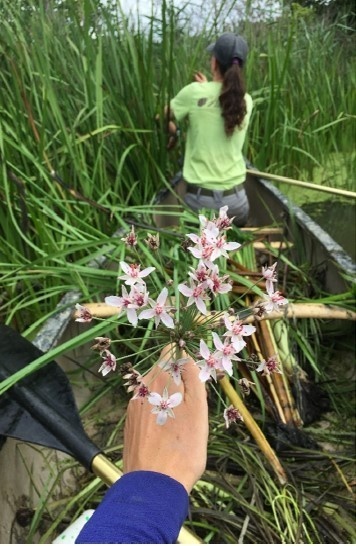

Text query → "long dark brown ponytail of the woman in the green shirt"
[217,59,247,136]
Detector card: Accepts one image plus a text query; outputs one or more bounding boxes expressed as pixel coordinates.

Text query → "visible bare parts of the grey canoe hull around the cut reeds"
[0,175,355,543]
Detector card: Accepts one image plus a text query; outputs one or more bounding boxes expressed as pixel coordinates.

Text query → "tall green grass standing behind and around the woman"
[0,0,356,328]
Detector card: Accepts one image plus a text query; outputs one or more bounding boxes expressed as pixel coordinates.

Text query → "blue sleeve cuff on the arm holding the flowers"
[75,470,189,544]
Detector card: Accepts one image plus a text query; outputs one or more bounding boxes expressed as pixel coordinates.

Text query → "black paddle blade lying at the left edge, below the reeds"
[0,324,100,470]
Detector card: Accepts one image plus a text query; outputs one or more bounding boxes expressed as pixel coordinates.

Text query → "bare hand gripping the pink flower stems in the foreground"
[123,345,209,494]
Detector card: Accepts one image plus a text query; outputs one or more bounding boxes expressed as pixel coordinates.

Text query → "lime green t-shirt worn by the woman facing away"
[170,82,252,190]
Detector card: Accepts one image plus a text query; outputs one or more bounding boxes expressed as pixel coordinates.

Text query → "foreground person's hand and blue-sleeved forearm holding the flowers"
[75,346,208,544]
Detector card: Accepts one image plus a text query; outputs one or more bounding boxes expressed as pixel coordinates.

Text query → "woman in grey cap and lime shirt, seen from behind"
[167,32,253,226]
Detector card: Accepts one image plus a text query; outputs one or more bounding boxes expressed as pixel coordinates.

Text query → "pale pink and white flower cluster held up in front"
[76,207,288,426]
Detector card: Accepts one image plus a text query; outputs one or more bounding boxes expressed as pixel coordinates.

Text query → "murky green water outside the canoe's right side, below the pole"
[300,199,356,261]
